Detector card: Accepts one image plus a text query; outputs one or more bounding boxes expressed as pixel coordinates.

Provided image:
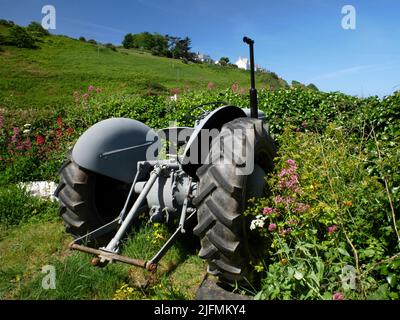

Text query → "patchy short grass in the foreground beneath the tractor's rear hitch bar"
[0,221,205,300]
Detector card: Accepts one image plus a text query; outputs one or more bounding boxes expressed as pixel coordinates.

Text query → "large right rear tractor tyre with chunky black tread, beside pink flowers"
[194,118,276,282]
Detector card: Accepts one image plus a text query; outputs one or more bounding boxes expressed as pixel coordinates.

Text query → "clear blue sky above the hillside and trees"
[0,0,400,96]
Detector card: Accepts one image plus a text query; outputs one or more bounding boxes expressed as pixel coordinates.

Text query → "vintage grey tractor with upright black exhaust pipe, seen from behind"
[55,37,276,283]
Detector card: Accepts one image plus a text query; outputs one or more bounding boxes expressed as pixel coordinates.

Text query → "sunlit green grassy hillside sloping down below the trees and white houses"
[0,26,287,109]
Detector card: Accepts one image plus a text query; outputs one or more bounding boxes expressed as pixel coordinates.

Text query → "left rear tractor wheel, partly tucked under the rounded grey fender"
[55,155,130,244]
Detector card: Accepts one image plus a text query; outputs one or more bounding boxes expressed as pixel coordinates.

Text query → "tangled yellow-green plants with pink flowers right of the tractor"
[246,124,400,299]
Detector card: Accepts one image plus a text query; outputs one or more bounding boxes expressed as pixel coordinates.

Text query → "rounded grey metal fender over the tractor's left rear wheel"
[72,118,160,183]
